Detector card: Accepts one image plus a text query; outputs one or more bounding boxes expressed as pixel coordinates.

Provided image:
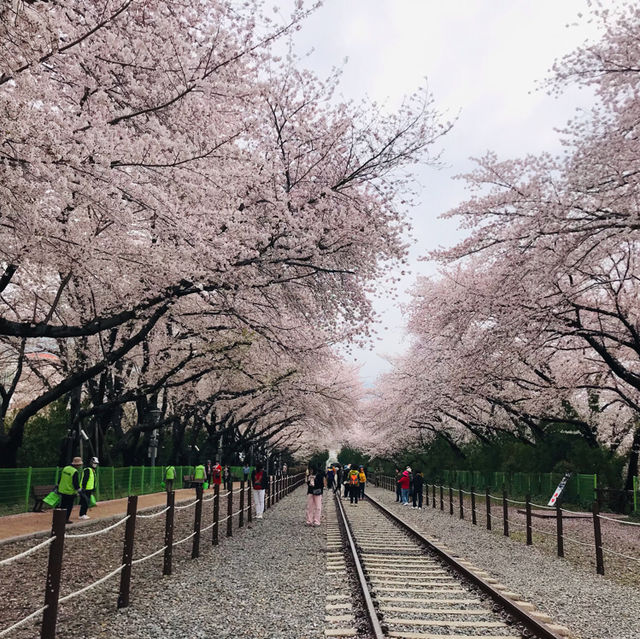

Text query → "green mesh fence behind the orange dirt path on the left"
[0,466,202,511]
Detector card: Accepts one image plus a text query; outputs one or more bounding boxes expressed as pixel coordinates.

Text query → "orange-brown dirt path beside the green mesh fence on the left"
[0,484,225,540]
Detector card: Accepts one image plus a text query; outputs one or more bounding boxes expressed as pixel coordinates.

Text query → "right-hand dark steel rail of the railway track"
[367,495,563,639]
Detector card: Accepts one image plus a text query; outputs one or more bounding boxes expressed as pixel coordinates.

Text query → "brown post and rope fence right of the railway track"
[376,475,640,575]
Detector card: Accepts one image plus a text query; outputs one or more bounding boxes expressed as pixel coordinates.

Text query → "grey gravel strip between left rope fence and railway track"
[93,488,326,639]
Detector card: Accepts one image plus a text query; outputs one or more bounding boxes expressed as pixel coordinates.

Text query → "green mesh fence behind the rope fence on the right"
[436,470,600,509]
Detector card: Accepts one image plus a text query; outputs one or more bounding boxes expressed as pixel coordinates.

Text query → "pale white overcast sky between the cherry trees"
[279,0,608,385]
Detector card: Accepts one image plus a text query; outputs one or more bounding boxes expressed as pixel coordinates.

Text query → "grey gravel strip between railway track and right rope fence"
[367,487,640,639]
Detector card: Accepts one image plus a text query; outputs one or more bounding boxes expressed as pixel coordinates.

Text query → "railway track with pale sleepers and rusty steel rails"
[325,497,562,639]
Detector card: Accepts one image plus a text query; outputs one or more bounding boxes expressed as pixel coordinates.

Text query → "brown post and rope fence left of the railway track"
[0,475,304,639]
